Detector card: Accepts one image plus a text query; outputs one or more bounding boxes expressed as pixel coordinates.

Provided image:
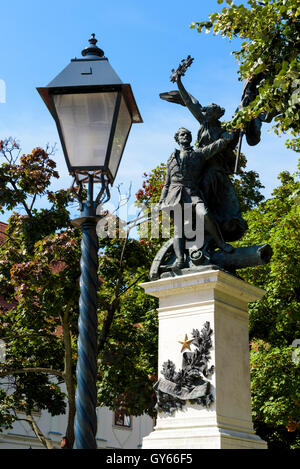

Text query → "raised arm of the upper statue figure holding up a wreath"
[160,55,205,124]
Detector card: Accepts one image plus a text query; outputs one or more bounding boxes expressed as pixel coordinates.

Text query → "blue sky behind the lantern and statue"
[0,0,297,219]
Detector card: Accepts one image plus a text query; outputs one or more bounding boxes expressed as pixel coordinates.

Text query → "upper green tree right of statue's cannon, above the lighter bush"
[239,165,300,345]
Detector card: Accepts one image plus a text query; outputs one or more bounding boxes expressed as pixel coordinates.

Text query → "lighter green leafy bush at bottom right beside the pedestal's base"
[250,339,300,449]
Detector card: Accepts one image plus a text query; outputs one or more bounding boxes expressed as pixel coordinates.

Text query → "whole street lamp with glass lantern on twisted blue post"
[37,34,142,449]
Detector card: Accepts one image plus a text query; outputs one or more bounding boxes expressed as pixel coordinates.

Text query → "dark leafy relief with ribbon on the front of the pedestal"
[154,321,214,414]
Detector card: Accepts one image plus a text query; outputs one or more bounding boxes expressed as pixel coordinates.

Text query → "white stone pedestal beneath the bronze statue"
[141,268,267,449]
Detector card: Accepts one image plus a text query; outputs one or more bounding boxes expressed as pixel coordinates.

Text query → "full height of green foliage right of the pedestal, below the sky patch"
[238,165,300,448]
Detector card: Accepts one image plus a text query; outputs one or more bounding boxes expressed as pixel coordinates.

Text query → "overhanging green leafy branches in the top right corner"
[190,0,300,151]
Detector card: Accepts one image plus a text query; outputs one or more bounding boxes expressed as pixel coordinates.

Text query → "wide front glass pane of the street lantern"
[53,92,117,169]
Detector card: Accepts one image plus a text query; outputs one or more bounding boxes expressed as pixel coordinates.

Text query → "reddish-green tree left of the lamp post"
[0,138,79,448]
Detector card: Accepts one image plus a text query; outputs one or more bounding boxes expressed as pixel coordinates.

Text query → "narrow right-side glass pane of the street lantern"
[108,96,132,178]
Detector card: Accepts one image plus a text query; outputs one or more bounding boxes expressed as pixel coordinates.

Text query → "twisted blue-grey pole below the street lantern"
[74,217,98,449]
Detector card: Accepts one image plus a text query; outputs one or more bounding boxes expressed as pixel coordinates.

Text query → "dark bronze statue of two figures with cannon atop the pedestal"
[150,56,272,279]
